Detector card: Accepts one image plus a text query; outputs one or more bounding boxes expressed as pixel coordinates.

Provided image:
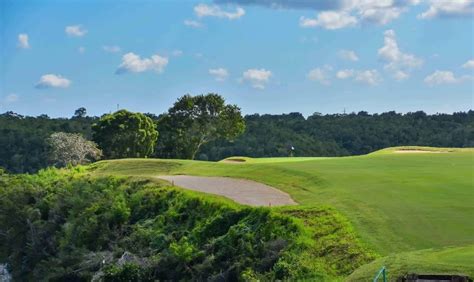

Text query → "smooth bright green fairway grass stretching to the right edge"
[95,147,474,278]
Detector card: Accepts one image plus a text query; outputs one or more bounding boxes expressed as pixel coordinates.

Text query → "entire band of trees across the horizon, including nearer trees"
[0,94,474,173]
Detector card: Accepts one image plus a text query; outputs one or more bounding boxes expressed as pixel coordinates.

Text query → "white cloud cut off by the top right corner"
[418,0,474,19]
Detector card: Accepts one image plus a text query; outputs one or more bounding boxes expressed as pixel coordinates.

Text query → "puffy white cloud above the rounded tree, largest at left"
[115,52,168,74]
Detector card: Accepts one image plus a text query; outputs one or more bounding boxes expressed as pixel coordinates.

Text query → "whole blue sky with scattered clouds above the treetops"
[0,0,474,117]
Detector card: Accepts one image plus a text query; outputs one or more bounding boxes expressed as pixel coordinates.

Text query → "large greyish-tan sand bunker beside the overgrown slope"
[157,175,296,207]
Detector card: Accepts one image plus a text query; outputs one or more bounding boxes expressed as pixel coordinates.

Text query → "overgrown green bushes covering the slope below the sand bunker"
[0,167,374,281]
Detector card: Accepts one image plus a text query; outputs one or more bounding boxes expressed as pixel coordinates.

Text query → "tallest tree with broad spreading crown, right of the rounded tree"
[157,93,245,159]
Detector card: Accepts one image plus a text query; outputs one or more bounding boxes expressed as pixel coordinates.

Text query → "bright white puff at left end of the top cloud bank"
[300,11,357,29]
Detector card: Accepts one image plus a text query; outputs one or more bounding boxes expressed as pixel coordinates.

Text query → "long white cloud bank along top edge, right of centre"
[300,0,420,29]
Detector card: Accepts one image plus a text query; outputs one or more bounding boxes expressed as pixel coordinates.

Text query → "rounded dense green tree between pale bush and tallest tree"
[92,110,158,159]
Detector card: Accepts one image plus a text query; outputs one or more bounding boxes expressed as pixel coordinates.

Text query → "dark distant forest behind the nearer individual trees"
[0,109,474,173]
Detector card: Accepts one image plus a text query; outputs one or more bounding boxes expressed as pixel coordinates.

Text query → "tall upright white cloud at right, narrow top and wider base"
[378,29,423,80]
